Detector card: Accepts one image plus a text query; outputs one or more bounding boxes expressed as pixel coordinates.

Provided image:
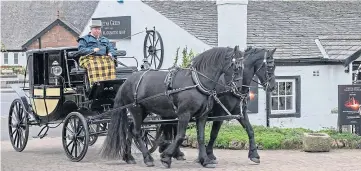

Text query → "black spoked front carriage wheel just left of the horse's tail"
[62,112,90,162]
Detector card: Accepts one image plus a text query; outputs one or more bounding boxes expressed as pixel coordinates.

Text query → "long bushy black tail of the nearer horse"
[100,98,128,159]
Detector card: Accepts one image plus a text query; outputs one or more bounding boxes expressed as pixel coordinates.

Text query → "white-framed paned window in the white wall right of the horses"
[271,79,296,114]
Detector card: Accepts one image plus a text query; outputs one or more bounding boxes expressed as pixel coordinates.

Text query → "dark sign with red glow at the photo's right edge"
[338,85,361,125]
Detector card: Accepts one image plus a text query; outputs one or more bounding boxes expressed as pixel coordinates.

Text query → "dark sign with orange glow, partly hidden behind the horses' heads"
[247,76,258,114]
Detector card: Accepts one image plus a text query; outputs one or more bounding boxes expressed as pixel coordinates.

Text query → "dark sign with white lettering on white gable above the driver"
[93,16,131,40]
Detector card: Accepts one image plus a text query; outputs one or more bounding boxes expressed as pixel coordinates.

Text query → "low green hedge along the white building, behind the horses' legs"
[183,123,361,149]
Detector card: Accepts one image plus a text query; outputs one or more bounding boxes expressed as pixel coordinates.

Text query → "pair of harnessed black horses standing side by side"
[101,46,276,168]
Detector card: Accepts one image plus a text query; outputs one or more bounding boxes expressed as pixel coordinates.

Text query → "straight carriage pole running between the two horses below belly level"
[143,115,241,125]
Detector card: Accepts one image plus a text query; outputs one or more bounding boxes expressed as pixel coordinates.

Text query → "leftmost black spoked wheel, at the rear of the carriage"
[8,99,29,152]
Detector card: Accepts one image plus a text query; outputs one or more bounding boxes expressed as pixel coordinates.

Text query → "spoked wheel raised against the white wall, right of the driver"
[143,30,164,69]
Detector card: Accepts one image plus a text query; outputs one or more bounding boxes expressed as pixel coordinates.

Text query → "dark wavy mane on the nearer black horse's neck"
[191,47,233,72]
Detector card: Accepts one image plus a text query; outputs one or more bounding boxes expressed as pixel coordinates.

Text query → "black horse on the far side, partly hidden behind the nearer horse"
[159,47,276,163]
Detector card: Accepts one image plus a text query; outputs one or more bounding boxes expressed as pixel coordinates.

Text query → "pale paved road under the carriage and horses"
[1,137,361,171]
